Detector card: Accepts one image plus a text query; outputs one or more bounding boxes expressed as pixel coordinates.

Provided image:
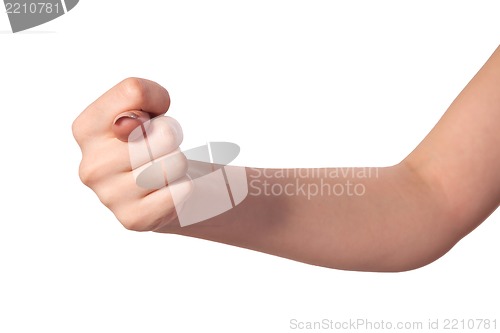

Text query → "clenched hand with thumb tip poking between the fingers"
[73,78,192,231]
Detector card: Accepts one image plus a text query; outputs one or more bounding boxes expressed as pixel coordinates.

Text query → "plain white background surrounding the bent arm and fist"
[0,0,500,333]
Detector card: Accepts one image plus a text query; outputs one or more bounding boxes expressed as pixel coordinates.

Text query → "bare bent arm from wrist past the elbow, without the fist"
[159,45,500,271]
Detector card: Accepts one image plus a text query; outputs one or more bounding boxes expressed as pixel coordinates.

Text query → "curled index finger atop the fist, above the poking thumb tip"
[75,78,170,136]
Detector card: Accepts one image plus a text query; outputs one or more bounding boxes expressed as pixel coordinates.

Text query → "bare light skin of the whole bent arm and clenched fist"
[73,48,500,271]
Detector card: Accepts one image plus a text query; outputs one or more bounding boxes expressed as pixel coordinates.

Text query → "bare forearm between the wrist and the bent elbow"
[160,164,456,271]
